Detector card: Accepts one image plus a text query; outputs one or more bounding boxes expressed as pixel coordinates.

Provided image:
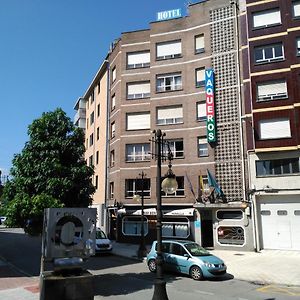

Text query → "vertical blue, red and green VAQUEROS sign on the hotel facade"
[205,69,217,143]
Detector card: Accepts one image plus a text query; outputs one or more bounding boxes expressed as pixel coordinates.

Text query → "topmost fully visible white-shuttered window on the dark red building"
[252,8,281,28]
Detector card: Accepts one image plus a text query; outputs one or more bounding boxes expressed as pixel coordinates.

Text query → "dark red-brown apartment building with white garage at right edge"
[242,0,300,250]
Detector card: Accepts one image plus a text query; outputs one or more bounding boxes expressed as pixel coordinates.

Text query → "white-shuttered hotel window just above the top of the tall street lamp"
[156,106,183,125]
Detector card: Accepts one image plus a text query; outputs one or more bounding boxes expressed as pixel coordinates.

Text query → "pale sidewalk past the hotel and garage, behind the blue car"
[113,242,300,286]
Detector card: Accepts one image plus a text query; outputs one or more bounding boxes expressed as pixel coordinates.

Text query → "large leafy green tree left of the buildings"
[4,108,95,232]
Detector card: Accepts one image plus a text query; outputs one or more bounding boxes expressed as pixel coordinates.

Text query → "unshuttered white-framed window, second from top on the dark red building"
[254,43,284,64]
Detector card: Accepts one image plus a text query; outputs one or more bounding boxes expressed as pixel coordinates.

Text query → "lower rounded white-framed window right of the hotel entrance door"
[217,226,245,246]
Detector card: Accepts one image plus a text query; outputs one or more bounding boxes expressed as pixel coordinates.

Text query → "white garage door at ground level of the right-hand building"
[258,196,300,250]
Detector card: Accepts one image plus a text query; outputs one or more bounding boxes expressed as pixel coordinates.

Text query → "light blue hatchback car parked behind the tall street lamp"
[147,240,227,280]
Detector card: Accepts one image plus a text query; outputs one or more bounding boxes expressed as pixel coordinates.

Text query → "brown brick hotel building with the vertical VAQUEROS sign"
[103,0,254,250]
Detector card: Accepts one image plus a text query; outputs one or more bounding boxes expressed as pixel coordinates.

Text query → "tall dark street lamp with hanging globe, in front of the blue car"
[152,129,178,300]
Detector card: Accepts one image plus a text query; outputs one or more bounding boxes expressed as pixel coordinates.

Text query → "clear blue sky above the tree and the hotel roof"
[0,0,189,175]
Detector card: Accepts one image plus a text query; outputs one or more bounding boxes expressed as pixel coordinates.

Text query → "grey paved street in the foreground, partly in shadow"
[0,228,300,300]
